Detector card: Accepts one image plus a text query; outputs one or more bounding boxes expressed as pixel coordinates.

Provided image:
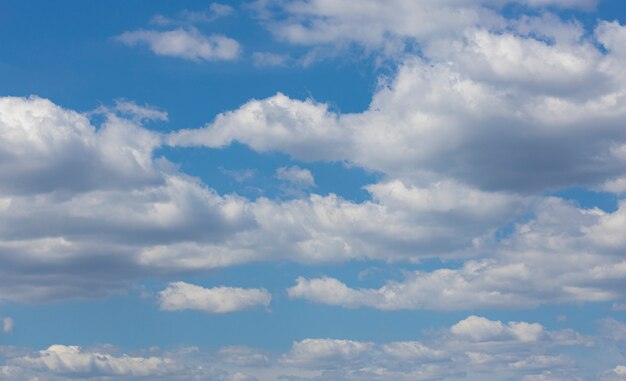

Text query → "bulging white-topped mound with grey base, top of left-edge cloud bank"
[0,97,161,195]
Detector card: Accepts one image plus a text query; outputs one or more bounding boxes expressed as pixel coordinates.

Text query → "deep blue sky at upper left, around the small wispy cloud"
[0,1,378,130]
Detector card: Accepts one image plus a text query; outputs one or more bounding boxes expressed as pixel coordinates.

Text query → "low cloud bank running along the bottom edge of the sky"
[0,316,600,381]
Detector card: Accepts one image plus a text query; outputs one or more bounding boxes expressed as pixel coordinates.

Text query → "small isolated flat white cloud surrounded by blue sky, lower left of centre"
[159,282,272,314]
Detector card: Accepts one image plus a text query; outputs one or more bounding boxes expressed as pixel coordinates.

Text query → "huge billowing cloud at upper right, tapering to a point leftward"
[168,20,626,193]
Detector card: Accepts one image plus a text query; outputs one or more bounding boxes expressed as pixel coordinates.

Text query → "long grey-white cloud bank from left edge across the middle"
[0,94,530,302]
